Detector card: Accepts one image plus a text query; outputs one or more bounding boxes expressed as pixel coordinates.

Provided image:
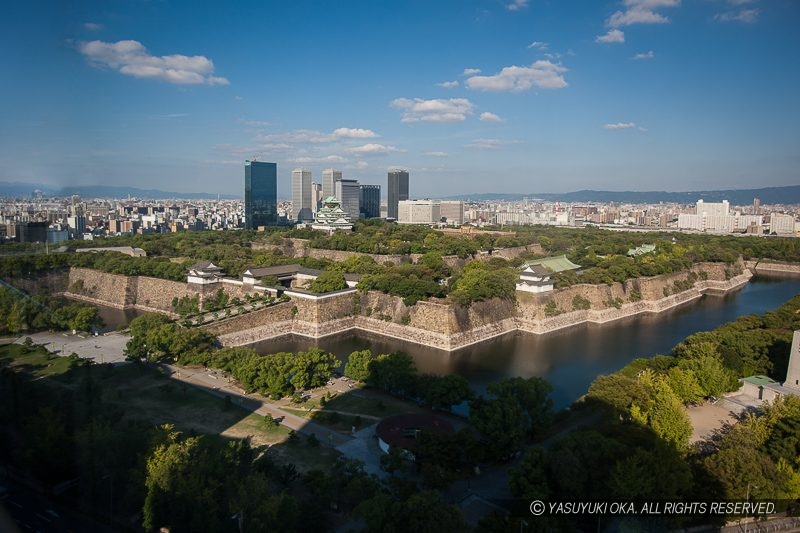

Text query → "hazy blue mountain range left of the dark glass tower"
[0,181,242,200]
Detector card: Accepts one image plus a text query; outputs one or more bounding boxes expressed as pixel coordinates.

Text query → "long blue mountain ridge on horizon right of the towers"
[449,185,800,205]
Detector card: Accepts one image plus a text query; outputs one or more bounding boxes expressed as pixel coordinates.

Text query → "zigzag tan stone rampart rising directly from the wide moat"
[208,265,752,351]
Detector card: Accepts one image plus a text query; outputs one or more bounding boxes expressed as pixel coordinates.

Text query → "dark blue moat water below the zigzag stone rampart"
[252,276,800,408]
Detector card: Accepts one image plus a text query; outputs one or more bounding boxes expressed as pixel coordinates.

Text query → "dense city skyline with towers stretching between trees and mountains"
[0,161,800,243]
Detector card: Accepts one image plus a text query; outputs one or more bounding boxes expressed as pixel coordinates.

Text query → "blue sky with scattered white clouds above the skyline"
[0,0,800,197]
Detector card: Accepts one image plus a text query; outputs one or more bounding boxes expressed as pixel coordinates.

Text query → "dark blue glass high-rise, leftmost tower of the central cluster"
[244,161,278,229]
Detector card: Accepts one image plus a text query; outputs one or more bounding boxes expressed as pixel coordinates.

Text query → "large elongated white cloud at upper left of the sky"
[78,40,229,85]
